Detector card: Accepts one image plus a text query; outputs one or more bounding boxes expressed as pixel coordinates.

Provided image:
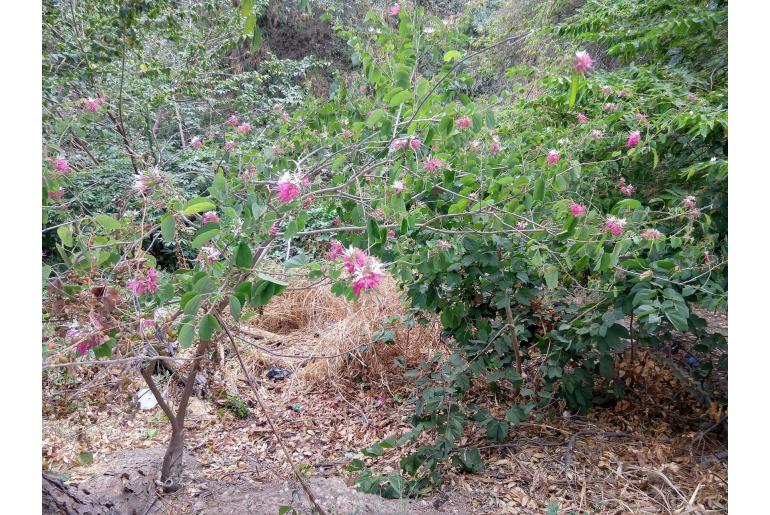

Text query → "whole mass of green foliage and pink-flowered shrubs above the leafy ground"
[43,0,728,497]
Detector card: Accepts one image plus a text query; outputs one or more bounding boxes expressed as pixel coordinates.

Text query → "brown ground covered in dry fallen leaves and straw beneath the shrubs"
[43,282,727,514]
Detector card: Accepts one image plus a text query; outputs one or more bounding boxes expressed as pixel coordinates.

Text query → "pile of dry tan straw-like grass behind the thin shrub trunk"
[234,275,446,384]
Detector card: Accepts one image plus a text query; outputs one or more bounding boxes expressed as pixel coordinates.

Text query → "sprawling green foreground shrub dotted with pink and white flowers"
[43,2,727,495]
